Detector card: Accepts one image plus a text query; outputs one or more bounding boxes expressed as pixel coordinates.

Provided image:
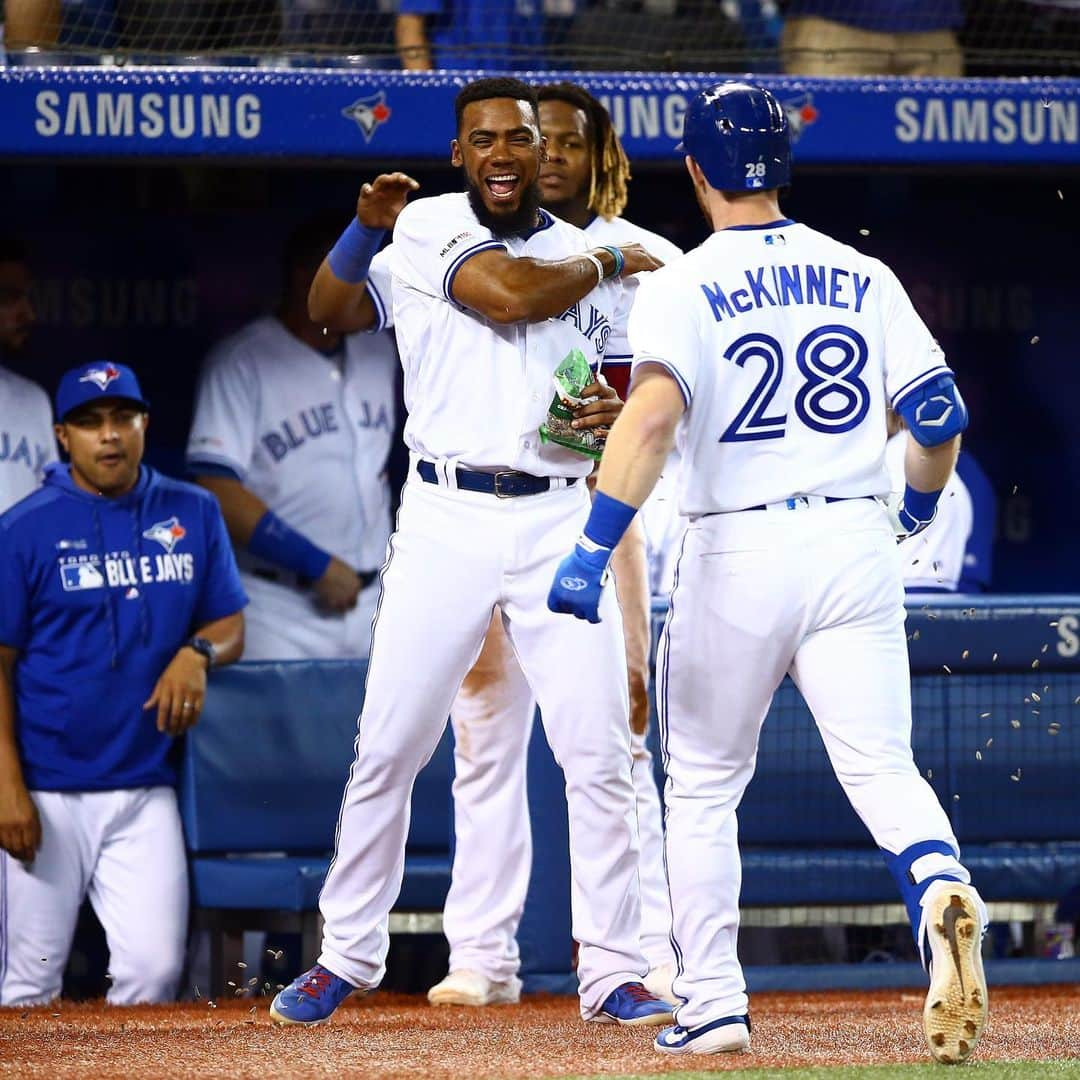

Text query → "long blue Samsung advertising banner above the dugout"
[0,67,1080,166]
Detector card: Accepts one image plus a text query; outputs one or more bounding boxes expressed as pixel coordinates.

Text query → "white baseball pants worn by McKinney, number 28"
[657,499,959,1027]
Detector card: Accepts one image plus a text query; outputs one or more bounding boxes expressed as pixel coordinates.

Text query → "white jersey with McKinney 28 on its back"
[630,219,949,516]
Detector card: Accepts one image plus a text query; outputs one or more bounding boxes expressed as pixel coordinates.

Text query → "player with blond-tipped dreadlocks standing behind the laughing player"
[428,83,683,1005]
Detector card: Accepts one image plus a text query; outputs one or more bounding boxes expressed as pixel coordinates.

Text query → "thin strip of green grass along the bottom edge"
[569,1059,1080,1080]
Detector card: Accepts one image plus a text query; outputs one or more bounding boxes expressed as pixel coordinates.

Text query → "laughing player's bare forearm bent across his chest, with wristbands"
[451,244,663,323]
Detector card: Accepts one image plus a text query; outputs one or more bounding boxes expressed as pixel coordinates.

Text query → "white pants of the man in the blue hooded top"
[0,787,188,1005]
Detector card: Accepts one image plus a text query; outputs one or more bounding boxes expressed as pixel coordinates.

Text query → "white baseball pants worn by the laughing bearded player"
[320,477,646,1017]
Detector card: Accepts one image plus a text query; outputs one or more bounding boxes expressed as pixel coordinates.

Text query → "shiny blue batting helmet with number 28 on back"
[676,82,792,191]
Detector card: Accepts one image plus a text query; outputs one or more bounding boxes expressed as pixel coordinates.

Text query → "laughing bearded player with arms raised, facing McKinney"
[271,79,671,1025]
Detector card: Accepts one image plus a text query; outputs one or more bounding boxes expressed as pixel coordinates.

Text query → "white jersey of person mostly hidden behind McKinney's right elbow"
[886,431,974,592]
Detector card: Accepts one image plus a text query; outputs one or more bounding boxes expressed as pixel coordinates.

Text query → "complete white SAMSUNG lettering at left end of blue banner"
[33,90,262,140]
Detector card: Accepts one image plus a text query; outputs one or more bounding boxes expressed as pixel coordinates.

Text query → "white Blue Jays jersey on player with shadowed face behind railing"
[188,316,396,570]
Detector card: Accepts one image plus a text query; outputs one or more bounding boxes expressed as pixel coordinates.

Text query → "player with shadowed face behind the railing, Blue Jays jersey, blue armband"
[188,220,397,660]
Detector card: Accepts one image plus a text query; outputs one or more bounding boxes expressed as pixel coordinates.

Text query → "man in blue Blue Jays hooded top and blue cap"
[0,363,245,1005]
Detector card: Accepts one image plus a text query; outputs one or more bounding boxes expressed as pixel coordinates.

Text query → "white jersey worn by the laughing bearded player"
[386,193,630,476]
